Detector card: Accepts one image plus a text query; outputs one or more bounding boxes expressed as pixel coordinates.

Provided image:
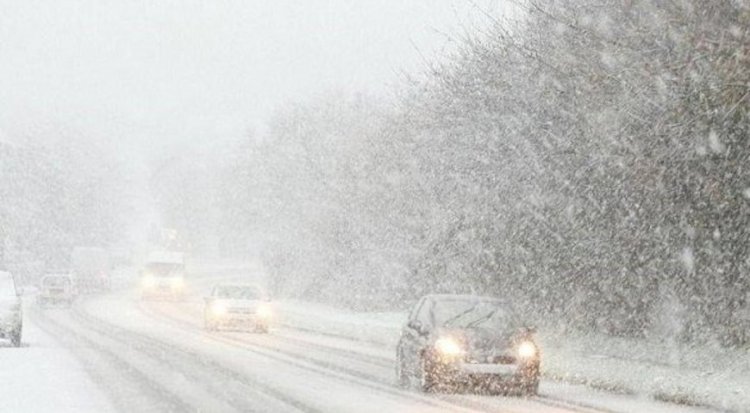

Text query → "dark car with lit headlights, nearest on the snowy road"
[396,295,541,395]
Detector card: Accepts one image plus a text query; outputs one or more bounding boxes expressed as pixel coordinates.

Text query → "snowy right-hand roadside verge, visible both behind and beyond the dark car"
[277,301,750,412]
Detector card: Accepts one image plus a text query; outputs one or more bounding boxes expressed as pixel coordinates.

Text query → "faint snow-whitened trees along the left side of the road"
[0,125,126,283]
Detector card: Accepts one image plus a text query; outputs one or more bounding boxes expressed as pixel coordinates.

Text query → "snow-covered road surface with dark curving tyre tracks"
[0,286,716,413]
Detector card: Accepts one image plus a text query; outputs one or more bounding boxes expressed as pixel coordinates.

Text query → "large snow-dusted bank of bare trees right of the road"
[155,0,750,345]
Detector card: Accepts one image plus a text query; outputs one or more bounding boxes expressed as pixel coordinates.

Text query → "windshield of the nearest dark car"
[432,299,512,328]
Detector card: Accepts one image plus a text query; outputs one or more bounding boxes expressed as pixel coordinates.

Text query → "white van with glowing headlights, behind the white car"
[141,251,185,300]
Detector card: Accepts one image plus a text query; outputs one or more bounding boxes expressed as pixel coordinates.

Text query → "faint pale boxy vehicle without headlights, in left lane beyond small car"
[71,247,112,293]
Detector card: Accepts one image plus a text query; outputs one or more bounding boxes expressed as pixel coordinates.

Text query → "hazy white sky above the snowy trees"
[0,0,506,153]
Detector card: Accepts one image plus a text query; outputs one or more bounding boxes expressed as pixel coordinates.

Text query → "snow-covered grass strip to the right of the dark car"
[540,333,750,411]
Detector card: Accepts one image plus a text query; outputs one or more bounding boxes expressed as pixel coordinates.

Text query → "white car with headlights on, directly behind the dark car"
[204,284,272,333]
